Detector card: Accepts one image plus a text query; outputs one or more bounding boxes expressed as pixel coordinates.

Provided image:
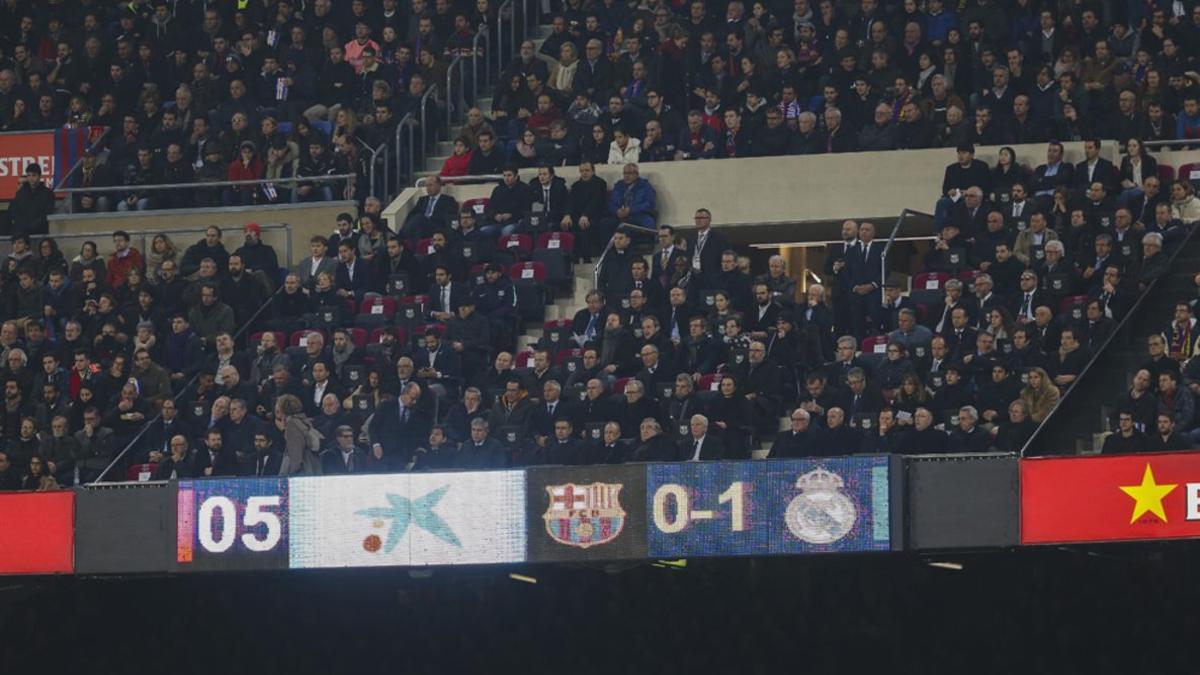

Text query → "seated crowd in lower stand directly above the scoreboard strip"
[0,130,1195,488]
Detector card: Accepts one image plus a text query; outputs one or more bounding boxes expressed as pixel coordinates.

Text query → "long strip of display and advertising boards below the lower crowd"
[7,453,1200,575]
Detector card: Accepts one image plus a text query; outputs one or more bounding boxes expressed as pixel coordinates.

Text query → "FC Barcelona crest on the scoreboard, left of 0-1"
[542,483,625,549]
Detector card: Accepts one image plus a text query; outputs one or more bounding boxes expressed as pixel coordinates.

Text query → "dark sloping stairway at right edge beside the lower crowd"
[1036,228,1200,454]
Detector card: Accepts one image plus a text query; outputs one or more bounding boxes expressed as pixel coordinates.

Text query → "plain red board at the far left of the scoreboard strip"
[0,490,74,574]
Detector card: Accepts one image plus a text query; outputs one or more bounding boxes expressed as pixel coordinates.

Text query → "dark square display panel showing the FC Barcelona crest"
[526,465,646,562]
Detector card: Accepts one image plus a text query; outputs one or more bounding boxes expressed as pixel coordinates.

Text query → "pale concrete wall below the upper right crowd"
[384,142,1113,233]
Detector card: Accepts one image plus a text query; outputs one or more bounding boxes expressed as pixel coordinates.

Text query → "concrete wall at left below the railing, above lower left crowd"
[50,202,359,267]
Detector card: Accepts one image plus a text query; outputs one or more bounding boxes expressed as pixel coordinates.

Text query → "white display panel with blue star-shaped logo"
[290,471,526,569]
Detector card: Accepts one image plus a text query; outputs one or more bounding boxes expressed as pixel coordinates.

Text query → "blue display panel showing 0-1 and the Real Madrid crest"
[646,456,898,557]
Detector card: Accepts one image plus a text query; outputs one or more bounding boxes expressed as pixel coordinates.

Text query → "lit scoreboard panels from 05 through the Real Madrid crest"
[166,455,901,571]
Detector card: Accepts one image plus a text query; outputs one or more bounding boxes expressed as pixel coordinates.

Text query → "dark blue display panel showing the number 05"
[175,478,288,571]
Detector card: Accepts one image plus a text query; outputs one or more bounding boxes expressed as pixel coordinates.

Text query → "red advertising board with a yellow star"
[1021,453,1200,544]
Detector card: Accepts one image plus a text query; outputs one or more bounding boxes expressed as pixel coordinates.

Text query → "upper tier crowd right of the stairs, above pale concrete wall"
[442,0,1200,172]
